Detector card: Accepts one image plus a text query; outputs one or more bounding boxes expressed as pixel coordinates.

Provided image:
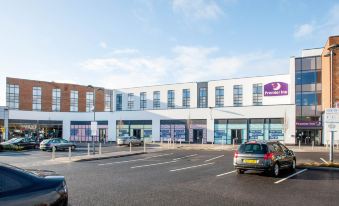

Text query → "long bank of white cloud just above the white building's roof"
[81,46,289,88]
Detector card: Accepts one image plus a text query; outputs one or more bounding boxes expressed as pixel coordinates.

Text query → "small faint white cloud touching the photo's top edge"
[172,0,224,19]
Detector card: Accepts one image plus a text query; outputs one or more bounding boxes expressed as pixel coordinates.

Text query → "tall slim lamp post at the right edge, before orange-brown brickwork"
[324,44,339,163]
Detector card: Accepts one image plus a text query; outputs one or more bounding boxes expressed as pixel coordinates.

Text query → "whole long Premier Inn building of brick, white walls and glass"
[0,36,339,145]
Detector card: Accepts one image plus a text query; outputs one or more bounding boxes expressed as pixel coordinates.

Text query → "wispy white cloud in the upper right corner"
[294,4,339,39]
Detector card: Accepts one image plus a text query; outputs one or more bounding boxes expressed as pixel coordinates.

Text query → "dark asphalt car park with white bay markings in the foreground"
[7,150,339,206]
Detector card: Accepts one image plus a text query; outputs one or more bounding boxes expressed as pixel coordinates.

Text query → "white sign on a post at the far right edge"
[325,108,339,163]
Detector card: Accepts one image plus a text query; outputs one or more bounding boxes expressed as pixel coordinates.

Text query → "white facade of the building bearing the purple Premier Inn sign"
[9,74,296,144]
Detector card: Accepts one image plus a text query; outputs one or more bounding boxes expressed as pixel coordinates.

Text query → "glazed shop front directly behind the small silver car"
[116,120,152,140]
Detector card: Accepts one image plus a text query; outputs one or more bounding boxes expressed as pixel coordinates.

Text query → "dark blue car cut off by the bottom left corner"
[0,163,68,206]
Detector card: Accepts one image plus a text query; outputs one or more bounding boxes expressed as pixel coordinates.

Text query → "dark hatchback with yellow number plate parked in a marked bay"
[233,141,296,177]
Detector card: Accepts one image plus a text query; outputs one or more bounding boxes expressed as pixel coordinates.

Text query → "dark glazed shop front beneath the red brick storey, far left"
[9,119,63,140]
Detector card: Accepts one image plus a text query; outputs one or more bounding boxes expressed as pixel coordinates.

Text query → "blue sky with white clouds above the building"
[0,0,339,105]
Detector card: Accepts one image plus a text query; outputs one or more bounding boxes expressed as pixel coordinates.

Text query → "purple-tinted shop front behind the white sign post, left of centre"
[70,121,108,142]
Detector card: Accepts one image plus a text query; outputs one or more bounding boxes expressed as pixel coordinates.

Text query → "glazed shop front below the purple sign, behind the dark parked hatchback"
[214,118,285,144]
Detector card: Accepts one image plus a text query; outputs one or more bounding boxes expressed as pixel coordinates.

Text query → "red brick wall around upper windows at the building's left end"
[6,77,105,112]
